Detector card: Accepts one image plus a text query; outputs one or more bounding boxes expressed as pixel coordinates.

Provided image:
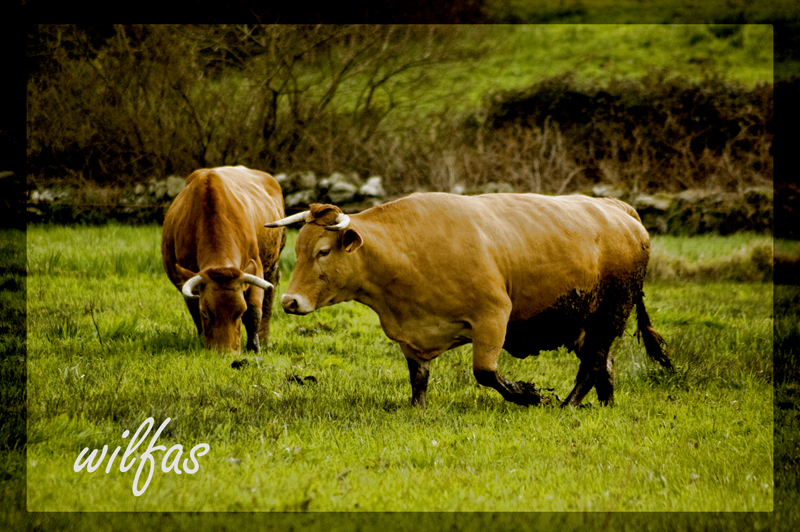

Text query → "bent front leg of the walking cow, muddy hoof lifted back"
[472,321,549,406]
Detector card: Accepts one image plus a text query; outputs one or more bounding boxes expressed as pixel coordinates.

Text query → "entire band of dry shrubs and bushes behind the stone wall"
[28,26,773,200]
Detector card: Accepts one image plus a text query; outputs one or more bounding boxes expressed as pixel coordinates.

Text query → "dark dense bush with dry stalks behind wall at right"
[485,73,773,190]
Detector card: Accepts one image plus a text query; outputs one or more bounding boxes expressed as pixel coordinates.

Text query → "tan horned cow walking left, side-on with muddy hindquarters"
[267,193,672,406]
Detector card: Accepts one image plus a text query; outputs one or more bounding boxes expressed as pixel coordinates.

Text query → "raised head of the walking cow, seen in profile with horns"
[266,203,363,314]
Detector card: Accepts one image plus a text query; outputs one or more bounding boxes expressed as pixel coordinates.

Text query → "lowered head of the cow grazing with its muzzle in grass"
[175,259,273,352]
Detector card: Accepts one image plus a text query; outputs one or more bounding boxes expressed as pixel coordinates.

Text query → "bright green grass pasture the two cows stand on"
[26,225,774,512]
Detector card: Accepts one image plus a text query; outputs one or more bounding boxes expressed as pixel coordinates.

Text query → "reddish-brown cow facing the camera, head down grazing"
[161,166,286,352]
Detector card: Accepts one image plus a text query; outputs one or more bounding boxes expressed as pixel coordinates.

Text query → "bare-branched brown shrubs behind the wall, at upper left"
[28,25,482,189]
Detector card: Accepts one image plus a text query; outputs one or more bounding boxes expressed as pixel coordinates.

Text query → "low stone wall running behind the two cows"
[28,172,780,238]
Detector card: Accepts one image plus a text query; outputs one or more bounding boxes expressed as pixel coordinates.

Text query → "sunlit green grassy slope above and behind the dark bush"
[296,23,773,123]
